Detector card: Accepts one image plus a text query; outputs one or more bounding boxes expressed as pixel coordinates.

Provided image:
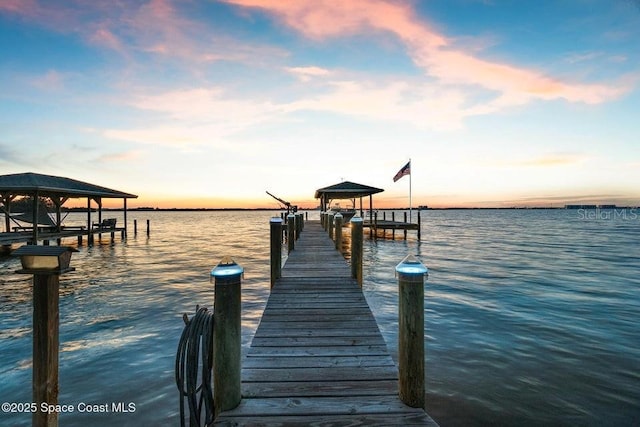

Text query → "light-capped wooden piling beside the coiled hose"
[211,257,244,416]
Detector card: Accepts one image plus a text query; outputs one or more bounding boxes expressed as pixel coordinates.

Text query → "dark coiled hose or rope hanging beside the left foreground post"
[175,306,215,427]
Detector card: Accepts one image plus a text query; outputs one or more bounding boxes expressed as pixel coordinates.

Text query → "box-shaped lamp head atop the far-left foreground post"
[12,245,78,274]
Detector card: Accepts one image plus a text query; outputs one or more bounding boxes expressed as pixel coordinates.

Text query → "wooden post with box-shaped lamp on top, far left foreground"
[12,245,77,427]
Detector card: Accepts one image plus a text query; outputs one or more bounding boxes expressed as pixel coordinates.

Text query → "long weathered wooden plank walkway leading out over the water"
[214,221,437,426]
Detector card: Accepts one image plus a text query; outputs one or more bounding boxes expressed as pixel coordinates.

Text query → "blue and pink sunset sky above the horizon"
[0,0,640,207]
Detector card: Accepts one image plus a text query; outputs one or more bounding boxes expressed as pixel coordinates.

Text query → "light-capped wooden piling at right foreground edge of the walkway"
[396,255,429,409]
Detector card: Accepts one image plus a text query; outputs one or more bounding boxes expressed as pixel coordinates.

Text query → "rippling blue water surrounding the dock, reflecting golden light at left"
[0,210,640,426]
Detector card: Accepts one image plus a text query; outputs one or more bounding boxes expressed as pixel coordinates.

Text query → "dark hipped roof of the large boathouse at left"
[0,172,138,199]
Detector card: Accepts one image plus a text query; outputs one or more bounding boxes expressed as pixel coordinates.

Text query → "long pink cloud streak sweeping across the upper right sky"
[224,0,628,108]
